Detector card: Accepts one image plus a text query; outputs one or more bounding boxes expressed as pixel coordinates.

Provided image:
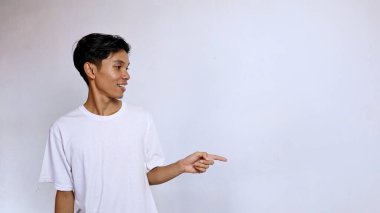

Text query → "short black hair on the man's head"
[73,33,131,85]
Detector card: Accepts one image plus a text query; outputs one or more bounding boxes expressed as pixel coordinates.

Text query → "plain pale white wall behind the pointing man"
[0,0,380,213]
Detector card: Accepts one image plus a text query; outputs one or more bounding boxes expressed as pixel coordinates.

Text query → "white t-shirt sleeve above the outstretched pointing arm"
[144,114,164,172]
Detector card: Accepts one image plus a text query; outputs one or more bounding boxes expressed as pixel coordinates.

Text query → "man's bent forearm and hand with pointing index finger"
[147,152,227,185]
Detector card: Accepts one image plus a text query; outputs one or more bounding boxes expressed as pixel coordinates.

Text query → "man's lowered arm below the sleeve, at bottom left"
[55,190,74,213]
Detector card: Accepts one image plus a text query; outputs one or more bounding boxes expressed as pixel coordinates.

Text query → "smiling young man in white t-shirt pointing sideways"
[40,34,227,213]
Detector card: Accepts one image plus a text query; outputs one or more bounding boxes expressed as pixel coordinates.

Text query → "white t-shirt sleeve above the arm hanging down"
[39,126,73,191]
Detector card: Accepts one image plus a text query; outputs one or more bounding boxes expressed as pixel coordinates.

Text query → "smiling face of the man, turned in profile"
[93,50,130,99]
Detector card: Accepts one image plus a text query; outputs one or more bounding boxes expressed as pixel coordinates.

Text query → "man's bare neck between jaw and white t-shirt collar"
[84,90,122,116]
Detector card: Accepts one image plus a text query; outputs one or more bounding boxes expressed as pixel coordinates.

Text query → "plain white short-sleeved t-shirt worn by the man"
[40,102,164,213]
